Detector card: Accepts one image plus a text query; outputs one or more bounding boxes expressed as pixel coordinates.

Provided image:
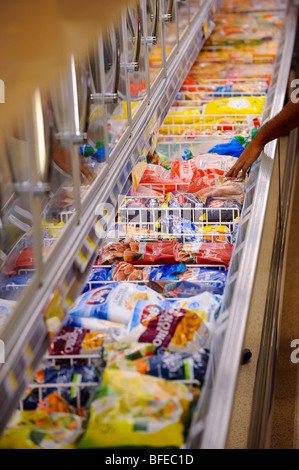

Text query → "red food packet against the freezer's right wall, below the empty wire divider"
[179,242,233,269]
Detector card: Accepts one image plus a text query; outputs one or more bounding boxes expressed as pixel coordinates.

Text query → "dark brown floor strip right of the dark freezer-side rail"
[271,151,299,449]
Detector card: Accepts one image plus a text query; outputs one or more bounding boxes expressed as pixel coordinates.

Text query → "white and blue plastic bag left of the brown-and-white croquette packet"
[65,282,163,328]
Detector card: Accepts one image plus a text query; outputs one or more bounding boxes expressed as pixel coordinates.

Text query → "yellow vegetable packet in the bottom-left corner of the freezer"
[0,409,83,449]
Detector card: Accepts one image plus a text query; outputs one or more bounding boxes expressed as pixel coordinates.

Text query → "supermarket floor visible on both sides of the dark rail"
[227,136,299,449]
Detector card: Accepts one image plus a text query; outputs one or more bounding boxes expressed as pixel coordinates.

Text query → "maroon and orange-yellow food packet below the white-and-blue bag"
[49,326,104,356]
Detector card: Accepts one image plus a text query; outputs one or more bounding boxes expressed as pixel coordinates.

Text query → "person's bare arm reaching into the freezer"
[226,101,299,179]
